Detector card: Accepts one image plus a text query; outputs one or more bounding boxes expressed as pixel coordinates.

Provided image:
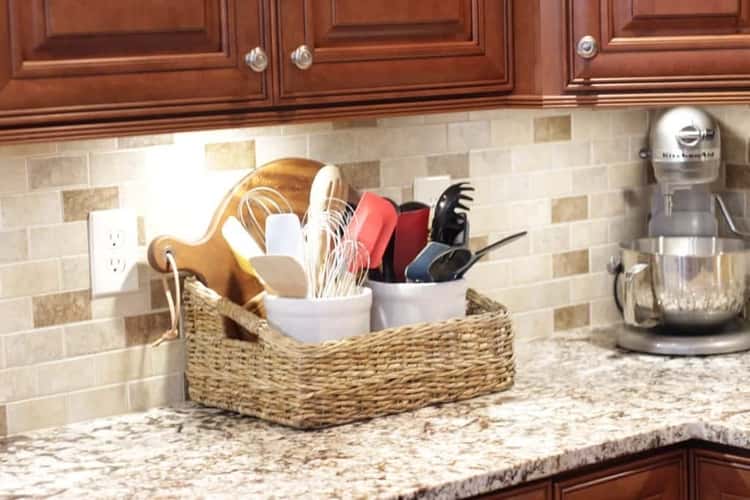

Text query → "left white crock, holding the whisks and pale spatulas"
[264,287,372,343]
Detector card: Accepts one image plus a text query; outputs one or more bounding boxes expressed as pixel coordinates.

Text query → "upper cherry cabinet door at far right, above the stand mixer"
[565,0,750,91]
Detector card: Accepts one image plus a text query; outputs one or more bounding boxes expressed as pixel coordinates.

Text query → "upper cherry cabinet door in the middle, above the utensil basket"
[276,0,512,104]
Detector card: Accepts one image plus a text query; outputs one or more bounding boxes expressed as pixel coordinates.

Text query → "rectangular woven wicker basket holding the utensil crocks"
[184,279,515,429]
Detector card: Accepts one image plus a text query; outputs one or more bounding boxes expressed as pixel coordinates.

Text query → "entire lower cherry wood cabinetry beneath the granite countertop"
[481,442,750,500]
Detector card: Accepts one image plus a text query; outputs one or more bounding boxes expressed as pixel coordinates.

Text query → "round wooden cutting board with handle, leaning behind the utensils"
[148,158,323,305]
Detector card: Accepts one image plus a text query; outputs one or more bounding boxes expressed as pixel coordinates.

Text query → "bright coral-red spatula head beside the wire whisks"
[346,192,398,269]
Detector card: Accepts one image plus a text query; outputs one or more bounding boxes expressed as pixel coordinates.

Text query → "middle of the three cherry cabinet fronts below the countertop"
[554,450,688,500]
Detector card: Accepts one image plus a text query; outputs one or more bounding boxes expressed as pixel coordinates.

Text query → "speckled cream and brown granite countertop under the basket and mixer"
[0,330,750,498]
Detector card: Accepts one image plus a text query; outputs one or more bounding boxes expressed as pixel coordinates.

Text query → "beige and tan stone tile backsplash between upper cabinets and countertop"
[0,106,750,435]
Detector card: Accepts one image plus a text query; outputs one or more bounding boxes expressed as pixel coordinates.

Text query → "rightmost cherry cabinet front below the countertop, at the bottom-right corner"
[691,450,750,500]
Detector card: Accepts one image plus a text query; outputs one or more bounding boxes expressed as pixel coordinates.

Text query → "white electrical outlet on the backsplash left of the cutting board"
[89,209,138,297]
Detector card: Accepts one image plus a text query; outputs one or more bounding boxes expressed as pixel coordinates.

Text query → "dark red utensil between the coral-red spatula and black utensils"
[394,202,430,282]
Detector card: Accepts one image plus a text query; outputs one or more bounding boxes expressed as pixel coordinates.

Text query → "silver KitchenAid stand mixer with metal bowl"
[610,106,750,355]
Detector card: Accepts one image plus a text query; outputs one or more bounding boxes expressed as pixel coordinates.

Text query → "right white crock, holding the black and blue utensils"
[367,280,468,331]
